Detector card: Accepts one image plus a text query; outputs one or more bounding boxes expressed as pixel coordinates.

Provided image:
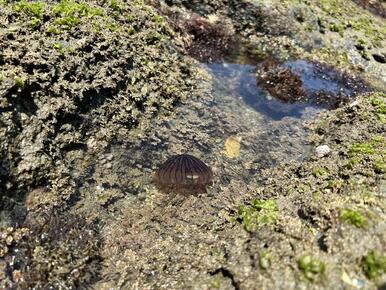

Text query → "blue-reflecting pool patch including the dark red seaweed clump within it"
[204,60,363,120]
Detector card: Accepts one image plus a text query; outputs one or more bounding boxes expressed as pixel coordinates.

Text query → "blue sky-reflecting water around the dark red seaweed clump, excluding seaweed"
[204,60,355,120]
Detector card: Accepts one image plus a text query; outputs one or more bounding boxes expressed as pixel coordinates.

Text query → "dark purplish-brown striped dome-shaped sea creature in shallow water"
[154,154,213,193]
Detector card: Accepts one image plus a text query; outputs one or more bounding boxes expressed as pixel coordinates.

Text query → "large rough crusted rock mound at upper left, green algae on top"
[0,2,193,199]
